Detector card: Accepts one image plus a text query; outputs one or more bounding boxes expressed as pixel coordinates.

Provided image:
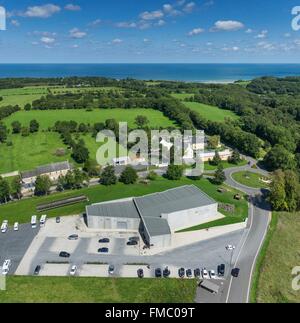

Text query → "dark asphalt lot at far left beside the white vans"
[0,224,39,274]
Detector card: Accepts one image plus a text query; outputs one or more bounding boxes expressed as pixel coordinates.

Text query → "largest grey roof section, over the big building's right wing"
[134,185,216,217]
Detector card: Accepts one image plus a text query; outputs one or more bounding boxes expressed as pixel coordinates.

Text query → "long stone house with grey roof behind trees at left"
[21,161,72,194]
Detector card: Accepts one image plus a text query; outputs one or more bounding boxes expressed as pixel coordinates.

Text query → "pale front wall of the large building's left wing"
[87,215,140,231]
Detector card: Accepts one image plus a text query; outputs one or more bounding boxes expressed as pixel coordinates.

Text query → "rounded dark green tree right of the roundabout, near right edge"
[264,145,296,171]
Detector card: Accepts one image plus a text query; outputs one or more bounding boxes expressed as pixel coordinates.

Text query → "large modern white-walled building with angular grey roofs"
[86,185,218,247]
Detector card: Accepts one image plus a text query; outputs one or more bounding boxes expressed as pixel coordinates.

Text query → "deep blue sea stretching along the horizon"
[0,64,300,83]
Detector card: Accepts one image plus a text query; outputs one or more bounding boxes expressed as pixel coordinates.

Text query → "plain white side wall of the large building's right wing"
[162,203,218,232]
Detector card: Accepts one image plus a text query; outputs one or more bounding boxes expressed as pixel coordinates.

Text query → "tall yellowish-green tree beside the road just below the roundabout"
[269,170,287,211]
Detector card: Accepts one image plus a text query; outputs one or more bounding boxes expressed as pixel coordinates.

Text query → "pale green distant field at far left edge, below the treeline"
[0,87,48,108]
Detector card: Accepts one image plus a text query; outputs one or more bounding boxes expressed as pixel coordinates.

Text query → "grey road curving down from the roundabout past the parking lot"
[221,165,271,303]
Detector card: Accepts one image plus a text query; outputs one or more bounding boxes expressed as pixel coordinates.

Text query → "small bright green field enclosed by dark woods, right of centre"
[184,102,239,122]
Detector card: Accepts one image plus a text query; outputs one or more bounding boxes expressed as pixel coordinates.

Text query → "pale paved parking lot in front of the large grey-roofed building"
[16,217,243,278]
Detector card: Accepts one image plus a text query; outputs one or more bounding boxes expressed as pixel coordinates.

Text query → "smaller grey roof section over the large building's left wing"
[86,200,140,218]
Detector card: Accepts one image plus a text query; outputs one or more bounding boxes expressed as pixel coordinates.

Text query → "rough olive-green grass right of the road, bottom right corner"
[252,213,300,303]
